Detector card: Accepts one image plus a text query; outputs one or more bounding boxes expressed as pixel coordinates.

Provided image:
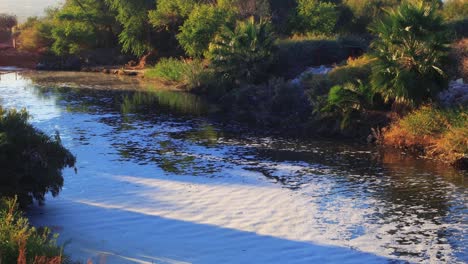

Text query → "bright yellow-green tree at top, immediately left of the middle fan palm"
[177,4,234,57]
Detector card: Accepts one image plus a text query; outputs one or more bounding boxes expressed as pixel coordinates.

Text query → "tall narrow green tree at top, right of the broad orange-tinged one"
[106,0,155,56]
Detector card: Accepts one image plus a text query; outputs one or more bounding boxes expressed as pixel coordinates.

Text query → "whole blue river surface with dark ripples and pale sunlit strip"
[0,72,468,263]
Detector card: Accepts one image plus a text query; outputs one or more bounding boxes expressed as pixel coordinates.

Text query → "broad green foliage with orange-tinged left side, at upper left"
[27,0,117,55]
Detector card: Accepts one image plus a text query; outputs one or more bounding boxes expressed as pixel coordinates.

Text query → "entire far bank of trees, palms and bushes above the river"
[4,0,468,169]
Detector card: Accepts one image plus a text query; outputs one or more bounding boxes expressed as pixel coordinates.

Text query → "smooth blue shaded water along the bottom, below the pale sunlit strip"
[30,201,405,264]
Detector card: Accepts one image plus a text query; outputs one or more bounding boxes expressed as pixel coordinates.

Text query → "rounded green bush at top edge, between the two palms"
[290,0,338,35]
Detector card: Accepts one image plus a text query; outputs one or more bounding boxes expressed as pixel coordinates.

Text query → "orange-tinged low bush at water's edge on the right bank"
[384,106,468,162]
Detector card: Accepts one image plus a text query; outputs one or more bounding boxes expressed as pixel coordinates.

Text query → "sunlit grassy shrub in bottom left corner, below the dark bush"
[0,199,66,264]
